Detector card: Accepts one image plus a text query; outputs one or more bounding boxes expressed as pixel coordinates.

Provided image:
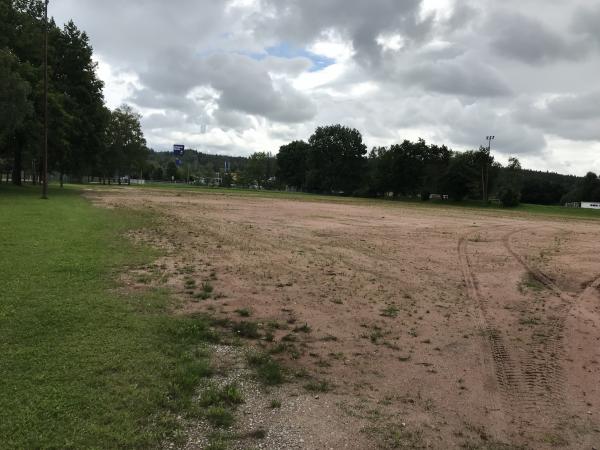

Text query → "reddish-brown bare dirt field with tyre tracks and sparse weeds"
[89,189,600,449]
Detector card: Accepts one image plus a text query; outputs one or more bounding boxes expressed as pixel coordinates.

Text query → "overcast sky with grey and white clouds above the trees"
[50,0,600,174]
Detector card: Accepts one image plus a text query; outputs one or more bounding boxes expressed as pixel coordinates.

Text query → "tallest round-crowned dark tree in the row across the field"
[306,125,367,194]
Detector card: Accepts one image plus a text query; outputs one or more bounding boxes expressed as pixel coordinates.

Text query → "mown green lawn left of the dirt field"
[0,185,218,449]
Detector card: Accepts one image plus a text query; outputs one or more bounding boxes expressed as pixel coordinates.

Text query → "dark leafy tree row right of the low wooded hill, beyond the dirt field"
[277,125,600,206]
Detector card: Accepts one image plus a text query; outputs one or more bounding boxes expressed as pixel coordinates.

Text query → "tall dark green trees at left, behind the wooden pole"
[0,0,147,185]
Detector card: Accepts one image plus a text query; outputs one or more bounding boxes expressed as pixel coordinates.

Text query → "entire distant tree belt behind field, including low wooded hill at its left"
[148,125,588,206]
